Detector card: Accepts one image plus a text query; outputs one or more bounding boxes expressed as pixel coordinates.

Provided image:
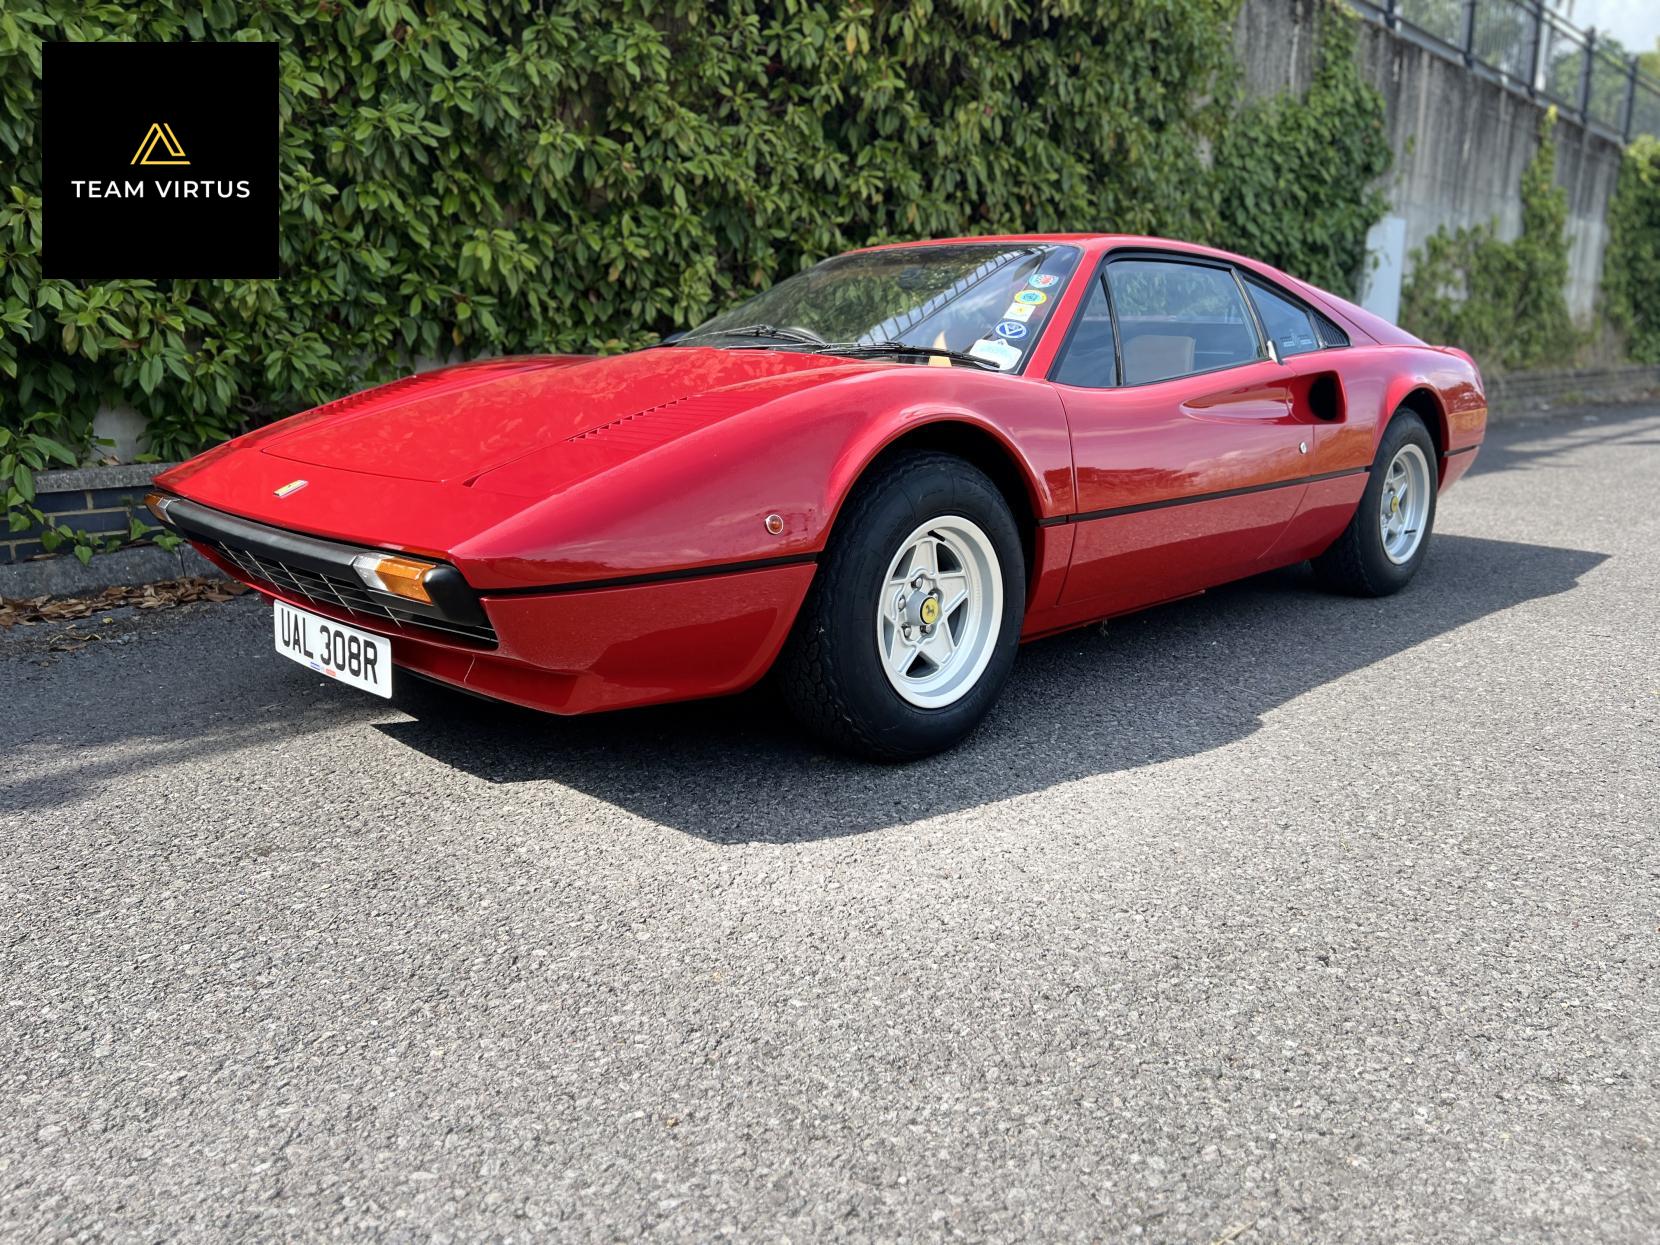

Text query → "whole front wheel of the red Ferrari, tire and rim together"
[779,453,1026,760]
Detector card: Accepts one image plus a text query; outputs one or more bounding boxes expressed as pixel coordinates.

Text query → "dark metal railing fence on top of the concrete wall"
[1351,0,1660,143]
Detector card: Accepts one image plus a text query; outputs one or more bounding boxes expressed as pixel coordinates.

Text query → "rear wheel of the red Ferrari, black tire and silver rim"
[1315,407,1439,596]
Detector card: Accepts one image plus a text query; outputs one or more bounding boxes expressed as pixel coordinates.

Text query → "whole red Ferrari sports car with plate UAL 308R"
[149,236,1487,760]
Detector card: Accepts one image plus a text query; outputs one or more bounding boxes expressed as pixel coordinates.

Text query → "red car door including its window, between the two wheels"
[1051,252,1308,614]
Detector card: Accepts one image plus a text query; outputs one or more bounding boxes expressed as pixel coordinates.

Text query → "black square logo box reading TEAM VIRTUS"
[42,43,277,281]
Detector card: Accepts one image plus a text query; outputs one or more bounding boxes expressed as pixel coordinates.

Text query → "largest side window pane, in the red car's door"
[1107,259,1262,385]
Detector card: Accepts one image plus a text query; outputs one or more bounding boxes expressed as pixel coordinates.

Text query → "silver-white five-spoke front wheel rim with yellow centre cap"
[876,515,1003,709]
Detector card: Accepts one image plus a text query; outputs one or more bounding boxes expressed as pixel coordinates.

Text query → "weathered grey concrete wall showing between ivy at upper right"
[1237,0,1620,322]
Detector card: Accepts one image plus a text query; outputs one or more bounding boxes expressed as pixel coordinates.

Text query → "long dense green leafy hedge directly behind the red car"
[0,0,1388,557]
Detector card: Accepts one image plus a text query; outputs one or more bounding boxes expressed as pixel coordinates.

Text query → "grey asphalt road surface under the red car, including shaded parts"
[0,407,1660,1242]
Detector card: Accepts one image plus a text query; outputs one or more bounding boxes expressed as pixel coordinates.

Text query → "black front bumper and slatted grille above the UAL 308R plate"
[166,498,496,647]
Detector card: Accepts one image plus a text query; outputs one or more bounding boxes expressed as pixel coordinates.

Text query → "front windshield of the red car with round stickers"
[679,242,1079,372]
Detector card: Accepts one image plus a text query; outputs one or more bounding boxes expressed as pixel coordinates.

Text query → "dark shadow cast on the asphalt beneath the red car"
[377,533,1605,843]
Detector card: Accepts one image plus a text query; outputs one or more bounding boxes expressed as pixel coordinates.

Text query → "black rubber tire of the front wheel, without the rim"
[777,452,1026,762]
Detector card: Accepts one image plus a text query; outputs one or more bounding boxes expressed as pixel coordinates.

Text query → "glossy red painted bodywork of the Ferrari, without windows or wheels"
[158,236,1486,714]
